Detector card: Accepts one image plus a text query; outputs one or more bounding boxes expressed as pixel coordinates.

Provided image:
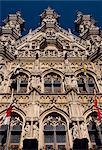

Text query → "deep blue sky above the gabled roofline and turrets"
[0,0,102,34]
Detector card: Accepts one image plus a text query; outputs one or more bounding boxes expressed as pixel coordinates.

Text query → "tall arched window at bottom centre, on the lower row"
[44,113,67,150]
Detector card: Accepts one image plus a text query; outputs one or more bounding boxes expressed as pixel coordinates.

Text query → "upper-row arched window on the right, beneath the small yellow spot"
[77,73,98,93]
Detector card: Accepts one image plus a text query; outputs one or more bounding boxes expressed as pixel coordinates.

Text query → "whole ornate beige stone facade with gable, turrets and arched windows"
[0,7,102,150]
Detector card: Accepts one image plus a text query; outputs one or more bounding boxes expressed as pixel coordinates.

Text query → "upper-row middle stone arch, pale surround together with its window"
[42,69,64,94]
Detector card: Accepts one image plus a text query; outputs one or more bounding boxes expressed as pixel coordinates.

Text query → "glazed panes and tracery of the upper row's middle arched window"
[44,73,61,94]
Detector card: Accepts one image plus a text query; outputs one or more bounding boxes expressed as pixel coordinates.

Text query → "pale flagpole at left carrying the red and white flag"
[6,88,14,150]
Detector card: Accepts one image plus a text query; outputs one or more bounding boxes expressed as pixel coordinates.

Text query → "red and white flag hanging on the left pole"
[3,104,13,125]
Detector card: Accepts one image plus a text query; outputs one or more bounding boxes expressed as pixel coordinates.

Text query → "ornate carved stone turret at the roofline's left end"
[0,11,24,43]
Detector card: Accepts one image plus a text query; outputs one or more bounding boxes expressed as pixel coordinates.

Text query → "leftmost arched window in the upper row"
[11,72,28,93]
